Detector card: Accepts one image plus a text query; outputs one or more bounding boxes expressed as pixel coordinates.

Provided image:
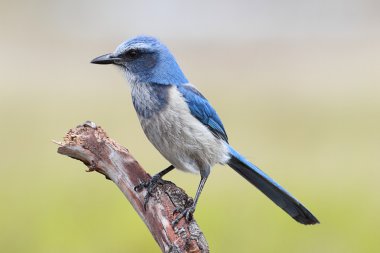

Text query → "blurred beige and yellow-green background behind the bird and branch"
[0,0,380,253]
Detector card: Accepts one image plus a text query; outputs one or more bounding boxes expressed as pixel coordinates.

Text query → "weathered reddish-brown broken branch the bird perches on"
[58,122,209,252]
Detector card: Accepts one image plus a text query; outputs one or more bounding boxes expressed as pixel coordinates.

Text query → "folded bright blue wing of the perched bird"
[177,84,228,143]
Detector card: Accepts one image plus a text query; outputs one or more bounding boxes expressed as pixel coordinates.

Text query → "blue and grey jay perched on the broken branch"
[91,36,319,224]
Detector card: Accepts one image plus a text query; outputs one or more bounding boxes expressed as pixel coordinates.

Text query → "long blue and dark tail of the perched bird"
[228,146,319,225]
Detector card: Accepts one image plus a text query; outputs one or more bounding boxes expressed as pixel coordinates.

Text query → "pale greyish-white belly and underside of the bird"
[132,86,230,174]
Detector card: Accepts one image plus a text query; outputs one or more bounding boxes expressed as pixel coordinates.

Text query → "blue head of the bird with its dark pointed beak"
[91,36,188,85]
